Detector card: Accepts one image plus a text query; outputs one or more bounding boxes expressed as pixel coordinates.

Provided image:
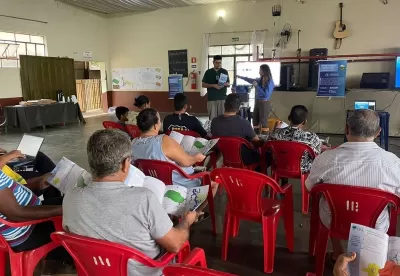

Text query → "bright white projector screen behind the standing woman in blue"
[236,61,281,86]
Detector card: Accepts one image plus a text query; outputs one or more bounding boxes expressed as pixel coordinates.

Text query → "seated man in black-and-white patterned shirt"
[268,105,321,172]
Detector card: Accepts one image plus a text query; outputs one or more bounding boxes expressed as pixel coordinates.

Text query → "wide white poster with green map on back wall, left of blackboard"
[112,67,162,91]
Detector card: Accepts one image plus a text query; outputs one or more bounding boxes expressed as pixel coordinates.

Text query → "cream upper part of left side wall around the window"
[0,0,109,98]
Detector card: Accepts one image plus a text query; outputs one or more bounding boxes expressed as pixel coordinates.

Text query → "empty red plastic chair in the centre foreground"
[211,168,294,273]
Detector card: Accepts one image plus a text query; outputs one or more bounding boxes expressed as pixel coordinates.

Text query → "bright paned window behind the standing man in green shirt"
[208,44,264,109]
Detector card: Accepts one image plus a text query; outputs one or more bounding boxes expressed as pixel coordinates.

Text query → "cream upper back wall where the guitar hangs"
[107,0,400,90]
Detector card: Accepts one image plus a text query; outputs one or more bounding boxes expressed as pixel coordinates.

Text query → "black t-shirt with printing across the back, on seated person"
[163,113,207,137]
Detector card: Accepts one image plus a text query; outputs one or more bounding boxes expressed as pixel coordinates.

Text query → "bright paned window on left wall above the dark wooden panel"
[0,32,47,68]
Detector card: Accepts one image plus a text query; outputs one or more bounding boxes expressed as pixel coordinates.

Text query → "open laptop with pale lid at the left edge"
[8,134,44,165]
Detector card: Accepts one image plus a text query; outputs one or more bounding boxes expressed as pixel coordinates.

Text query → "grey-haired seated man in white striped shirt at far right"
[306,109,400,260]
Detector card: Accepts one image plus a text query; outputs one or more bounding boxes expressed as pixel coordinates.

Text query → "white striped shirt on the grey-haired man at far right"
[306,142,400,232]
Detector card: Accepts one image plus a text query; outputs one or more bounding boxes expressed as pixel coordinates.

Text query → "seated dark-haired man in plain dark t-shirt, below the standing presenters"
[211,94,264,165]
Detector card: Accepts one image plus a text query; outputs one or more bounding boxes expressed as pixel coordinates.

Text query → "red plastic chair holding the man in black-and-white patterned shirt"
[261,141,315,214]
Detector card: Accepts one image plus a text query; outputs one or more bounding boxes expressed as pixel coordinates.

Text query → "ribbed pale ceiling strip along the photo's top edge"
[56,0,239,14]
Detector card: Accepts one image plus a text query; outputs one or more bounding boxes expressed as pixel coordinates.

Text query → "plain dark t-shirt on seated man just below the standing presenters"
[211,115,256,141]
